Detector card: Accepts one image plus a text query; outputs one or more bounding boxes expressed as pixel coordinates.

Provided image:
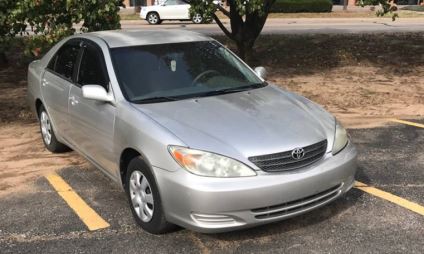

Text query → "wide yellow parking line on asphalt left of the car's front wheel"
[46,174,110,230]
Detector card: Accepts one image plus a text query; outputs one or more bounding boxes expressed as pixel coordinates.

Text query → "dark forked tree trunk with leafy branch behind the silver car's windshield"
[187,0,276,61]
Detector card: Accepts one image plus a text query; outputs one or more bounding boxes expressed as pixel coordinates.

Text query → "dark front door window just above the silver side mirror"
[78,44,109,89]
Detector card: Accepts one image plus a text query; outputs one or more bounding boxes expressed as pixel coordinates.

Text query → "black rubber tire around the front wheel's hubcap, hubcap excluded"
[125,157,176,234]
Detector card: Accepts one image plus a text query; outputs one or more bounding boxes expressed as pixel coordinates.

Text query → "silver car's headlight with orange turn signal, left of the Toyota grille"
[169,146,256,177]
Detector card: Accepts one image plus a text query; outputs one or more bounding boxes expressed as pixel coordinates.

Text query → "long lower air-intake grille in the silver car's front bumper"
[251,183,343,219]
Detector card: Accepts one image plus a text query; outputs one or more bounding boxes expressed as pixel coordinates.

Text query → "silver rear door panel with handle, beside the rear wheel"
[41,71,72,139]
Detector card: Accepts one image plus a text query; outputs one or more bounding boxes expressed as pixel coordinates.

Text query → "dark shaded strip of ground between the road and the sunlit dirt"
[216,33,424,75]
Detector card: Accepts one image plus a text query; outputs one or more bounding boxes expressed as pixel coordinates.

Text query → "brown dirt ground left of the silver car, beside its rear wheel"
[0,66,88,197]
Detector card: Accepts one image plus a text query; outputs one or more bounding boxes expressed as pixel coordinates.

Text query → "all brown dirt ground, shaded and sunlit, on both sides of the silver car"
[0,34,424,197]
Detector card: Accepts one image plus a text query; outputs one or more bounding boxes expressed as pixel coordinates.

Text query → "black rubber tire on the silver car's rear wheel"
[38,105,71,153]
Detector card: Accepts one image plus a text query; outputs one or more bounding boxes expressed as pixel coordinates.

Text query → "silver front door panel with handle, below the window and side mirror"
[69,85,116,177]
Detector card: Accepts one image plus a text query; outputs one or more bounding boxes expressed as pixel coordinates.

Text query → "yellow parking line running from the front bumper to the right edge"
[355,181,424,215]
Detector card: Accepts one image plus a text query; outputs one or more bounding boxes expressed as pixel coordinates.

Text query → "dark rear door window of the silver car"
[48,44,80,79]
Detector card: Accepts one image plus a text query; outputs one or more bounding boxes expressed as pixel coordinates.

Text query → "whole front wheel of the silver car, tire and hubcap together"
[125,157,175,234]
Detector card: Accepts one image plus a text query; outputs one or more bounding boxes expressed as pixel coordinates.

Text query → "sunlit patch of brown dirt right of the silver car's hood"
[271,66,424,128]
